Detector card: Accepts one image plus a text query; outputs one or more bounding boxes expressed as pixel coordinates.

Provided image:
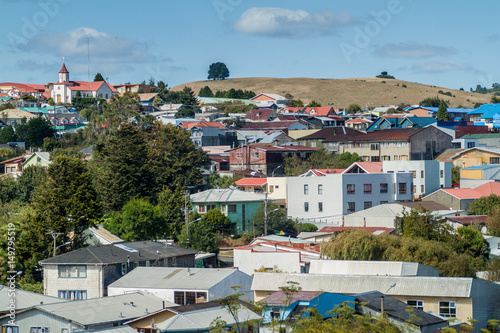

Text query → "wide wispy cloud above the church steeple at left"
[23,27,151,64]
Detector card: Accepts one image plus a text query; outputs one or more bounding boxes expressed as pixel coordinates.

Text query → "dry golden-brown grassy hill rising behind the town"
[172,77,491,108]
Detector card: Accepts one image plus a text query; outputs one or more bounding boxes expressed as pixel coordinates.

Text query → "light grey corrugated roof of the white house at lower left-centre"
[109,267,250,290]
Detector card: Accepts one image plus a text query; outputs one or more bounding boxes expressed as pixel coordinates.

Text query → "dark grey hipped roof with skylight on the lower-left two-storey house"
[40,241,198,265]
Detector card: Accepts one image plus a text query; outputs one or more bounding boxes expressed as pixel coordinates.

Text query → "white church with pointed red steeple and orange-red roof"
[49,63,118,104]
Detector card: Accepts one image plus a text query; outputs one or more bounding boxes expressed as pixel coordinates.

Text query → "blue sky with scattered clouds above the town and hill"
[0,0,500,90]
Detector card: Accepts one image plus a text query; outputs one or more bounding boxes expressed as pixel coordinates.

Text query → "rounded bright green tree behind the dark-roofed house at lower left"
[104,198,168,242]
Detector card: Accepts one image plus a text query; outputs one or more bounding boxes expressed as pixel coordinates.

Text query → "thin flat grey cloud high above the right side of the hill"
[375,42,457,59]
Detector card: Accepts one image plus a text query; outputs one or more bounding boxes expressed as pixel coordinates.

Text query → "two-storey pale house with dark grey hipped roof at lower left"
[40,241,197,300]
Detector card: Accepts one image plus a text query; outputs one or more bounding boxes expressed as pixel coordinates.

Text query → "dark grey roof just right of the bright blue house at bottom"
[355,291,446,327]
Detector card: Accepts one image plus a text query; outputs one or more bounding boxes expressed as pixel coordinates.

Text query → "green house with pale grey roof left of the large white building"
[191,188,265,235]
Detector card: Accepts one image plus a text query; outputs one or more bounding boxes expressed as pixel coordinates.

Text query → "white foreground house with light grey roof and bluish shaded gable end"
[108,267,252,305]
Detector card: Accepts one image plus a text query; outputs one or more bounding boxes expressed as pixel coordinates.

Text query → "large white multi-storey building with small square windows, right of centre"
[287,172,413,222]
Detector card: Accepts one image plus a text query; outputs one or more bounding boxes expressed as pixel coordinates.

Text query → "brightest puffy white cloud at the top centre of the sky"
[234,8,356,38]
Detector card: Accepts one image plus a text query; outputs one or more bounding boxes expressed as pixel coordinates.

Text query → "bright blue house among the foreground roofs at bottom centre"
[261,290,356,324]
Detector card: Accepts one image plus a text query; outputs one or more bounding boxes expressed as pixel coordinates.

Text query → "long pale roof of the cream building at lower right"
[251,273,474,297]
